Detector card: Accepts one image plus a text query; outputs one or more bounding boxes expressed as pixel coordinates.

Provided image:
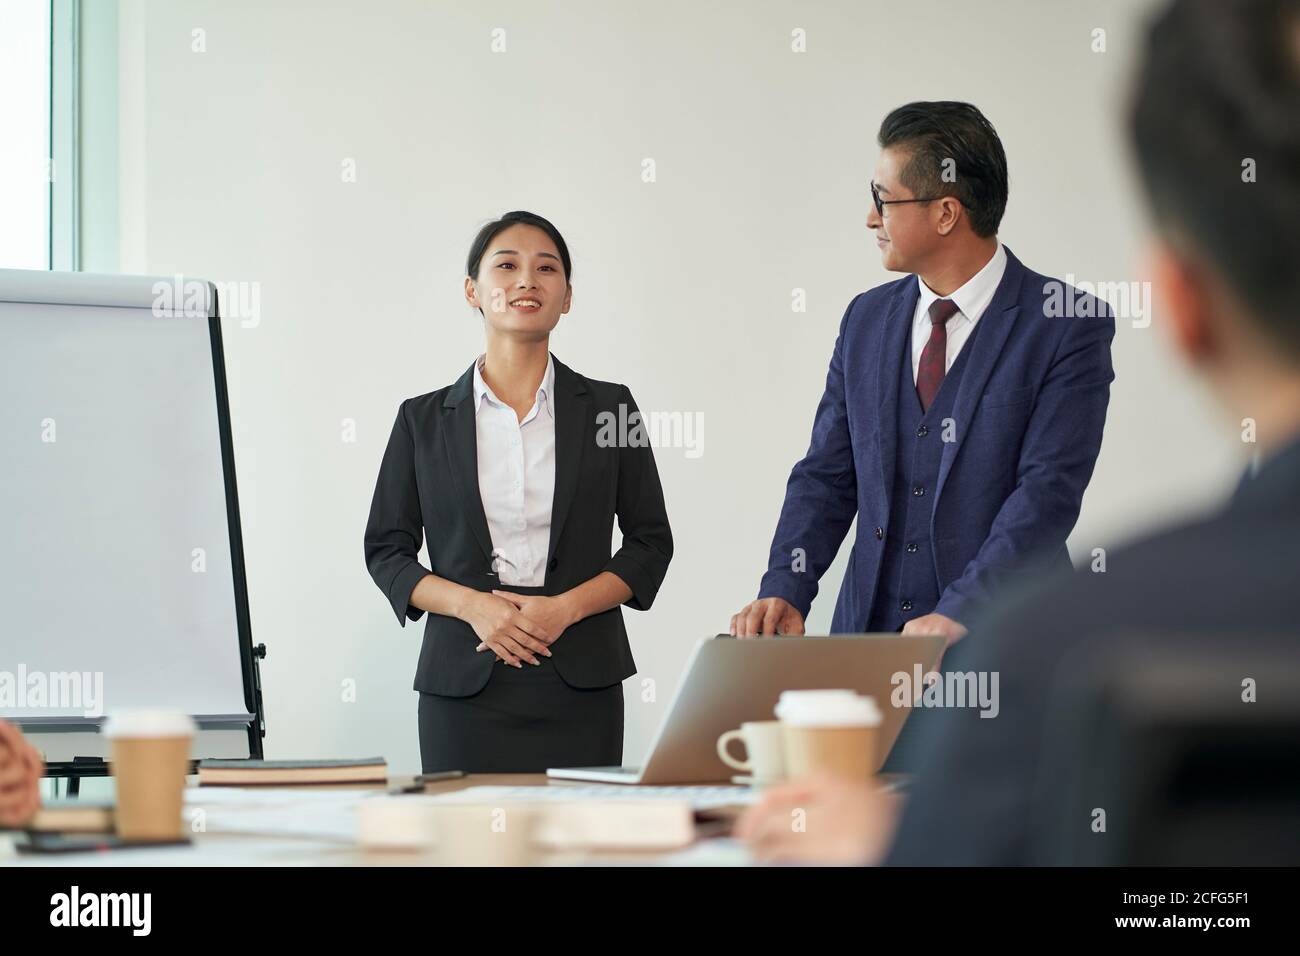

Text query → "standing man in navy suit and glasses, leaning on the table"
[731,103,1115,658]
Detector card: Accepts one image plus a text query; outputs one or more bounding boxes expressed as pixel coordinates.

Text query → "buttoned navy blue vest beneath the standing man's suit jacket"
[867,323,984,633]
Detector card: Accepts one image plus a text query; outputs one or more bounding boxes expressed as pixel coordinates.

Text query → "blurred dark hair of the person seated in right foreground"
[1130,0,1300,358]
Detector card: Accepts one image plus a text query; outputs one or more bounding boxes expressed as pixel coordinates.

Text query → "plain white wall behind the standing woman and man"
[88,0,1243,770]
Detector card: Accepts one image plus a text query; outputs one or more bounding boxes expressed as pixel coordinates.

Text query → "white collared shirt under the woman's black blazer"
[475,355,555,587]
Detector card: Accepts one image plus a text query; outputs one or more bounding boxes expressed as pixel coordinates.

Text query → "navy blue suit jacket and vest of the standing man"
[759,250,1115,633]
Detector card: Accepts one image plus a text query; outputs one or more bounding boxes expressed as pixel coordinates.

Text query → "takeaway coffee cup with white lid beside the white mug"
[776,691,881,780]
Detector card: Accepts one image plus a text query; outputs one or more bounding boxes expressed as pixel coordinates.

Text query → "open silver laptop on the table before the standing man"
[546,633,944,784]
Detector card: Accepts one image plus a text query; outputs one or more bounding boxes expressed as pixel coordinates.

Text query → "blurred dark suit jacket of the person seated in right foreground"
[885,438,1300,866]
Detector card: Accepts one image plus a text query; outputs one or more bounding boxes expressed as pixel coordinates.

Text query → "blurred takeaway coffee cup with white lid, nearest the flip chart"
[104,710,194,843]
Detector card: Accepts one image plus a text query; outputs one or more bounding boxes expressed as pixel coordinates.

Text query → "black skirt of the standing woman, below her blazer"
[420,650,623,774]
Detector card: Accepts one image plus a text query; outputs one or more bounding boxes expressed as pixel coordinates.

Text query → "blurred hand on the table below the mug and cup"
[732,773,902,866]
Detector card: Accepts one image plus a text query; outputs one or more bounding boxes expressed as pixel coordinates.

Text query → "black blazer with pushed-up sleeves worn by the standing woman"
[365,356,672,697]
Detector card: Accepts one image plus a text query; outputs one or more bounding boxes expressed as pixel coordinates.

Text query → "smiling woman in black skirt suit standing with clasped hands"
[365,212,672,773]
